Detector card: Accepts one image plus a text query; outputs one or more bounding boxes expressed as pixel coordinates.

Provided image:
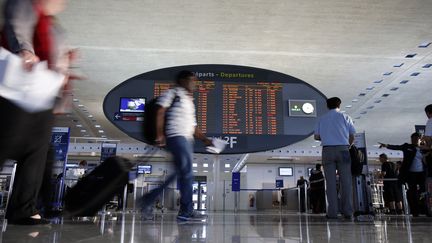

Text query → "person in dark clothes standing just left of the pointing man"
[379,153,403,214]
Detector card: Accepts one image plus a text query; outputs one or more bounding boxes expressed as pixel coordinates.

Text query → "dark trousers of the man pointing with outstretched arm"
[407,172,426,215]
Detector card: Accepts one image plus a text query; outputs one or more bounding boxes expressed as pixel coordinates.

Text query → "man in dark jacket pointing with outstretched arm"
[380,133,426,217]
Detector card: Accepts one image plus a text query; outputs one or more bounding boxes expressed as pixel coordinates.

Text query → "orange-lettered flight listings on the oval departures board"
[154,80,286,135]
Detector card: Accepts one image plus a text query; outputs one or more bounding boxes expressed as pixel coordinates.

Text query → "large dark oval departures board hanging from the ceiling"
[103,64,327,154]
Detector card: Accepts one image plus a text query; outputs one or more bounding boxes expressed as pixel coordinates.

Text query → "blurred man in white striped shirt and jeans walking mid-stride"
[142,71,212,221]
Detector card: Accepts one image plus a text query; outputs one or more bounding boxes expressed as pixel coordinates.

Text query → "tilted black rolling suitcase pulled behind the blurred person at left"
[65,157,132,217]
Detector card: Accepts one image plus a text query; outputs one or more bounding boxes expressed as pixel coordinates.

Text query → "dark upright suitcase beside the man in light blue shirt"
[353,175,374,221]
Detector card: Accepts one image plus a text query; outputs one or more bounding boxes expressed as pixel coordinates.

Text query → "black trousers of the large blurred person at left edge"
[0,97,53,220]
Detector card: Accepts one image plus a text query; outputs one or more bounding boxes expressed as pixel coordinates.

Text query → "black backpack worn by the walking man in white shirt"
[143,90,180,145]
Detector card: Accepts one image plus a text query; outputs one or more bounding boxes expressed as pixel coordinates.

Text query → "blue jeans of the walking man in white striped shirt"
[144,136,193,215]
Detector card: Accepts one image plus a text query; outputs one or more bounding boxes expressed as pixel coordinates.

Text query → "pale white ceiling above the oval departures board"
[51,0,432,160]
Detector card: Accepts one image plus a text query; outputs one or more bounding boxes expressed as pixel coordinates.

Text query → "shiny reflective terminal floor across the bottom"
[0,212,432,243]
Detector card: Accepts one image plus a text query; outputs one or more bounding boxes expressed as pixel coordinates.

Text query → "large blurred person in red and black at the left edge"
[0,0,75,225]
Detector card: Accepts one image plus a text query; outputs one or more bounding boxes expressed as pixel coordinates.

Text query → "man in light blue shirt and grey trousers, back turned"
[314,97,355,219]
